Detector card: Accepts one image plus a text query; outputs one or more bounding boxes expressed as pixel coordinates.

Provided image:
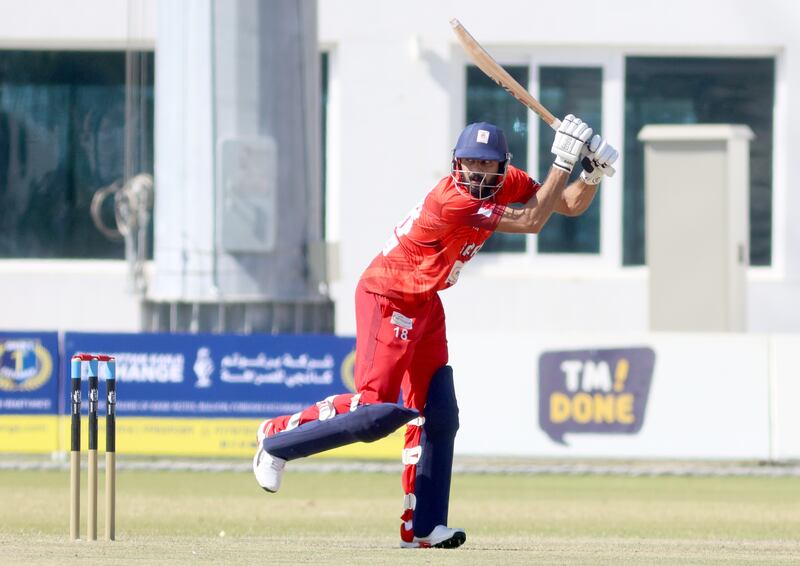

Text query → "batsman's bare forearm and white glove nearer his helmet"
[496,114,593,234]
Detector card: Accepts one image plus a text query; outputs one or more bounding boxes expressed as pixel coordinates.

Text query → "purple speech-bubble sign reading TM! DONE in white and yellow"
[539,348,656,444]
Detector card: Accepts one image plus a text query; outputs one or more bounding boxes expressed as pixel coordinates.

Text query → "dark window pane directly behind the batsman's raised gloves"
[536,67,603,254]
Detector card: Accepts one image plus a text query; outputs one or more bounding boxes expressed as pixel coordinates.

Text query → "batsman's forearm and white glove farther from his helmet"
[555,135,619,216]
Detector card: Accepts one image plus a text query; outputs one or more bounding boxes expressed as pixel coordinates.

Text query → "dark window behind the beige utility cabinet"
[623,57,775,265]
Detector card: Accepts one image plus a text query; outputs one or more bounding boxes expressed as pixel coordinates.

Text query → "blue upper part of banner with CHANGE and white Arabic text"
[62,332,355,419]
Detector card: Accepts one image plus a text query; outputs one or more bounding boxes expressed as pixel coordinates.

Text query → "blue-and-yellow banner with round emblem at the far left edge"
[0,332,59,453]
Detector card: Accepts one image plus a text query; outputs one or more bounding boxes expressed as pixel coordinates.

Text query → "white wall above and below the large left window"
[0,0,156,332]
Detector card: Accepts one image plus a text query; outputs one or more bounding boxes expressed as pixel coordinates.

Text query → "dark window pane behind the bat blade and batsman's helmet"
[466,66,528,253]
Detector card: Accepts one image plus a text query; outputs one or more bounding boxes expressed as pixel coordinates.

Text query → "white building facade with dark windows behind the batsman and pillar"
[0,0,800,334]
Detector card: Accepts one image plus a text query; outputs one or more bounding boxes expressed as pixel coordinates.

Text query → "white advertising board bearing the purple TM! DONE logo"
[449,333,772,460]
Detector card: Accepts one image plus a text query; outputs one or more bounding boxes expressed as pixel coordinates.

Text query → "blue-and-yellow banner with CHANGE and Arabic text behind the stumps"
[62,332,402,458]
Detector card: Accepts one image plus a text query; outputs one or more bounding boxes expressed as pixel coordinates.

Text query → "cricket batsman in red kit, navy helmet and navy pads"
[253,114,619,548]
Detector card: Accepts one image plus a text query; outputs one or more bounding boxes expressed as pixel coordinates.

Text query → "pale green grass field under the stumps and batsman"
[0,469,800,566]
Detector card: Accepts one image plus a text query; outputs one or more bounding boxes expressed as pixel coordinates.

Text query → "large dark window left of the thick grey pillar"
[0,51,153,258]
